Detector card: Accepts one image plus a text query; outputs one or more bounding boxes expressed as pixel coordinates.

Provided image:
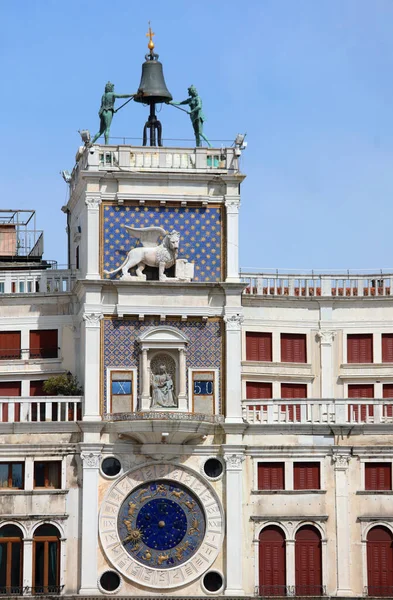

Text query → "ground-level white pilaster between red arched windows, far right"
[333,454,352,596]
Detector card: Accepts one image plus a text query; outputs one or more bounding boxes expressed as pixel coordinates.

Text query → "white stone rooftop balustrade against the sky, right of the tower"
[241,271,393,298]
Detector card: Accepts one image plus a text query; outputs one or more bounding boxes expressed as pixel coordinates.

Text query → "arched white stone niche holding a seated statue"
[138,325,189,412]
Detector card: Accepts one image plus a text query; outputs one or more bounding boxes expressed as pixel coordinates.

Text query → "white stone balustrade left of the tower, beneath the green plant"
[0,396,82,423]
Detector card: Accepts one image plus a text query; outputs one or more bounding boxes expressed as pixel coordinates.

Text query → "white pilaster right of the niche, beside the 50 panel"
[224,313,243,423]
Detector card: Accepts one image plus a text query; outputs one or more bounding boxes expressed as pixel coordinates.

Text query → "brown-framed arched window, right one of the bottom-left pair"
[33,524,60,594]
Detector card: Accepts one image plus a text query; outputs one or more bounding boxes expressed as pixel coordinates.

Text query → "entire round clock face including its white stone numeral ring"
[99,464,223,588]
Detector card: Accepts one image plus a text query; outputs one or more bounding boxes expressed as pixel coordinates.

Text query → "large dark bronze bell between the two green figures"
[134,53,172,105]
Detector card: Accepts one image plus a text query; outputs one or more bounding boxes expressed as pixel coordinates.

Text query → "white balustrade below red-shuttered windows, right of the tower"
[242,398,393,425]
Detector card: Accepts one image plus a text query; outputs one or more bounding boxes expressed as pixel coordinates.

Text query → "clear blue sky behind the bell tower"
[0,0,393,269]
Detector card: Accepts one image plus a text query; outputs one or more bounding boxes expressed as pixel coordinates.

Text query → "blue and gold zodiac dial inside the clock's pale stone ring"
[118,480,206,569]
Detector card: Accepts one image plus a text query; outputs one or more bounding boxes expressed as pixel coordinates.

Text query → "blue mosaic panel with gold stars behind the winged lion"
[103,203,224,282]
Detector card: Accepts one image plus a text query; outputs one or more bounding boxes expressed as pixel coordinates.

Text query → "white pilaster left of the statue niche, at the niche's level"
[83,313,103,421]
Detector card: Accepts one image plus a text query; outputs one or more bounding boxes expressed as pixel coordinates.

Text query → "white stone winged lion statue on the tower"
[104,225,180,281]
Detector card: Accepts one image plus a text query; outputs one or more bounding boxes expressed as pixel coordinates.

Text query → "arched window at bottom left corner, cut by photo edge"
[0,525,23,595]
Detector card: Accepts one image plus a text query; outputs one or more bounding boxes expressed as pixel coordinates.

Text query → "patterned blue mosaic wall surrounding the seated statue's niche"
[103,317,223,413]
